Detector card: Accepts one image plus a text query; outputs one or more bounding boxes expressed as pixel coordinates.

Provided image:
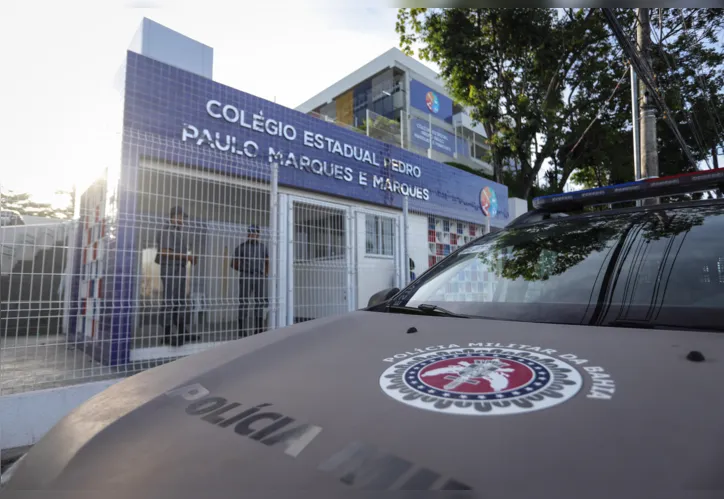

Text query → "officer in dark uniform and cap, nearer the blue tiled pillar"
[156,206,197,346]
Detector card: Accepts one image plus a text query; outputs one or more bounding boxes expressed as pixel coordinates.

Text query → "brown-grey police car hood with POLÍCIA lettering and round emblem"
[8,311,724,499]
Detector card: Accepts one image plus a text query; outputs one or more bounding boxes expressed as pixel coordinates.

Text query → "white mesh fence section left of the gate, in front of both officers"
[0,120,286,395]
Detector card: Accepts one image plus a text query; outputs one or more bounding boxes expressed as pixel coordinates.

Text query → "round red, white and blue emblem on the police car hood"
[380,348,583,416]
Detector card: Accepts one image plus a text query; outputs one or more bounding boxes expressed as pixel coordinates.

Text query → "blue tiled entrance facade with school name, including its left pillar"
[93,52,508,365]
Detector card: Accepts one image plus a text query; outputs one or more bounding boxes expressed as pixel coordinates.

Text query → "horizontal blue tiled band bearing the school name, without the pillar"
[124,52,508,226]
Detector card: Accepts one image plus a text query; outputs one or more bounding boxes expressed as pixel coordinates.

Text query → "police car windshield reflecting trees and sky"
[395,203,724,331]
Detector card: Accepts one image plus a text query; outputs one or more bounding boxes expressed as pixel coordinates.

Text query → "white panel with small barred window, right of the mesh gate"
[355,210,404,308]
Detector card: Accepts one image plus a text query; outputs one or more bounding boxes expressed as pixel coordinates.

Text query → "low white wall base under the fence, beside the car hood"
[0,379,120,450]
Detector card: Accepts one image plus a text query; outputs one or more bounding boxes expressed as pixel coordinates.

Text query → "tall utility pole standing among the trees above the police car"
[636,8,659,186]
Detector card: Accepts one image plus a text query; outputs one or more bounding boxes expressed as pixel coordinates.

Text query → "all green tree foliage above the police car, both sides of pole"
[397,8,724,200]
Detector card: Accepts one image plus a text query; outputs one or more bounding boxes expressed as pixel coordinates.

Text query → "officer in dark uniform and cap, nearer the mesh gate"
[231,225,269,336]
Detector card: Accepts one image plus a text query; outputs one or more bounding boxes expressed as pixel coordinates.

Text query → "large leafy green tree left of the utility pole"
[397,8,624,199]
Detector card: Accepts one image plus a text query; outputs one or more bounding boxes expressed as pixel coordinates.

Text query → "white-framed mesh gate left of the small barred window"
[287,197,353,324]
